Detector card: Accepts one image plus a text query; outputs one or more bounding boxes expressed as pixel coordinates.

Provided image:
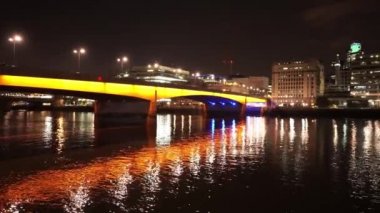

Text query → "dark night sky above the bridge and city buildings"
[0,0,380,76]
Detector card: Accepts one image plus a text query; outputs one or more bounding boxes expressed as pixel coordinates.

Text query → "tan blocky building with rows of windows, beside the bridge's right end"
[272,60,324,107]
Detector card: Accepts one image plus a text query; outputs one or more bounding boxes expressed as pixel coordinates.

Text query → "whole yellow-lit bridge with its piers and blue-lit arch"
[0,74,266,116]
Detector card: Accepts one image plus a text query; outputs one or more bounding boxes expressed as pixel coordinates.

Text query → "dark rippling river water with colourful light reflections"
[0,112,380,212]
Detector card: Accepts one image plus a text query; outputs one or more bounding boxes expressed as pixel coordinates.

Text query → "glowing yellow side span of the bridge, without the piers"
[0,75,266,104]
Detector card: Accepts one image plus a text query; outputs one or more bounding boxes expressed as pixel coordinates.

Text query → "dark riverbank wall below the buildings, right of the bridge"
[263,108,380,118]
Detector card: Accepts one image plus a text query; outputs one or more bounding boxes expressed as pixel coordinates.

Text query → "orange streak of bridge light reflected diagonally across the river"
[0,119,266,210]
